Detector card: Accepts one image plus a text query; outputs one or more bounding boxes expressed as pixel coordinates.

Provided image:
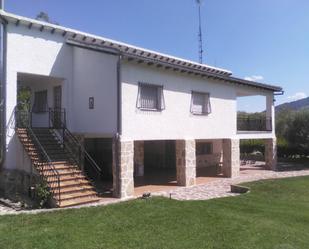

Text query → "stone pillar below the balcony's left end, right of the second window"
[222,139,240,178]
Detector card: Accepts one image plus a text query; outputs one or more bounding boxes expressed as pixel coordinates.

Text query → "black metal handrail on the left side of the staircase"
[16,110,61,205]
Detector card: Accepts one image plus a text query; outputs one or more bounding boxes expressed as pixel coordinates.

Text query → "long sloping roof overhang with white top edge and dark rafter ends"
[0,10,282,92]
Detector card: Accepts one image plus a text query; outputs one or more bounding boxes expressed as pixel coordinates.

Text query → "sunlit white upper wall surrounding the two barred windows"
[121,62,273,140]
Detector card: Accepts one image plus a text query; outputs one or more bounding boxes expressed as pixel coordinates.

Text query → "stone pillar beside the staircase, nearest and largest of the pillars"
[113,138,134,198]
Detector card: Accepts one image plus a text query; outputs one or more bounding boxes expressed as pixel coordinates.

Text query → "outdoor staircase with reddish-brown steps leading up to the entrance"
[16,128,101,207]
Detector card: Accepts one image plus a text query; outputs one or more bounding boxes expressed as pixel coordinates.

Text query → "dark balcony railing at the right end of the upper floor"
[237,117,272,131]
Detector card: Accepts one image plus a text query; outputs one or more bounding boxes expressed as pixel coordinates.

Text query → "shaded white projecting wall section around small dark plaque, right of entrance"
[72,47,118,137]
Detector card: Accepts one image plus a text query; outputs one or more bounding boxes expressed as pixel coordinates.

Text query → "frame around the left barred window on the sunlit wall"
[136,82,165,111]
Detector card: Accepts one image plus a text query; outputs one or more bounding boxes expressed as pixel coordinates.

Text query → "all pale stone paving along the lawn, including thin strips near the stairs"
[0,166,309,215]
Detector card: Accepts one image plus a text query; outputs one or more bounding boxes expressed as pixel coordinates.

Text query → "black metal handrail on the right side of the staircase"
[49,108,102,176]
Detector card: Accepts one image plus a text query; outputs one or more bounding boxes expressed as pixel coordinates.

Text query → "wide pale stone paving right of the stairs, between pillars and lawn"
[155,166,309,200]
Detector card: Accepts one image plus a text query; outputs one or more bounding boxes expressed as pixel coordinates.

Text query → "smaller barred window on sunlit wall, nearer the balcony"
[191,92,211,115]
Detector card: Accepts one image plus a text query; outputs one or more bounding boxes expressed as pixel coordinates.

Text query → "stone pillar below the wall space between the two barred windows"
[176,140,196,186]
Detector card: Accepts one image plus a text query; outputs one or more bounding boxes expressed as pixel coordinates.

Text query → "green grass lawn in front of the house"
[0,177,309,249]
